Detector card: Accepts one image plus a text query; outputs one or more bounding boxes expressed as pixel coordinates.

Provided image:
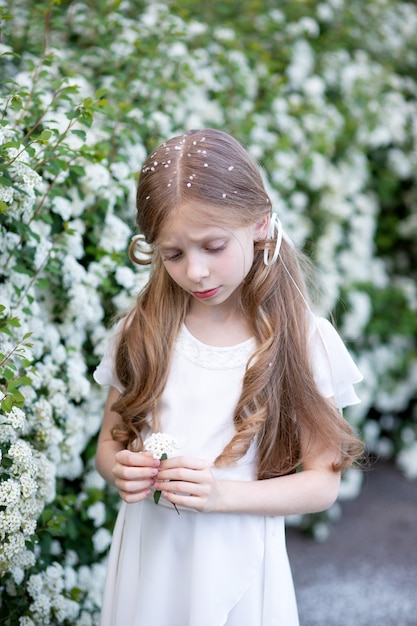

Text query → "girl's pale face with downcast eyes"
[156,203,268,306]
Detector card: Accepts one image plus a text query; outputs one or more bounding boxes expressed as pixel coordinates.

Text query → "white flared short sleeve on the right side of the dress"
[309,317,363,408]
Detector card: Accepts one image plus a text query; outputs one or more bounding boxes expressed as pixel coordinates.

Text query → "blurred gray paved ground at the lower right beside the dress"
[287,463,417,626]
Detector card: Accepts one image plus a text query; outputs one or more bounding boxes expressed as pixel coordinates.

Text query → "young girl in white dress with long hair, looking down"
[95,129,362,626]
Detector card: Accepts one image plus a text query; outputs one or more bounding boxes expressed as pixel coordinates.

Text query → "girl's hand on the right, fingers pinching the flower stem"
[154,456,219,513]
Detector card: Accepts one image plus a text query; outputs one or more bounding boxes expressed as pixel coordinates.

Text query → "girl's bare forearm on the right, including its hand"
[155,442,340,515]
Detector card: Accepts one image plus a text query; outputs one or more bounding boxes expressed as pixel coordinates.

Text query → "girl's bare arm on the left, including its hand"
[96,387,160,503]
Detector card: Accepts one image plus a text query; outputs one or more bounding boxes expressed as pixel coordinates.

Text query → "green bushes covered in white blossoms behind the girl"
[0,0,417,626]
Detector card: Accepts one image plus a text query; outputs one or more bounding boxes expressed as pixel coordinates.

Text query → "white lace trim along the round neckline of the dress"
[175,326,255,369]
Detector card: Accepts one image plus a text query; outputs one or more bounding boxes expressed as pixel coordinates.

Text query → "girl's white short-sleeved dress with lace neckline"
[94,318,362,626]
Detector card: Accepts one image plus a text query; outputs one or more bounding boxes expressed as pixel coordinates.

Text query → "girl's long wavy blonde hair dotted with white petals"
[112,129,362,479]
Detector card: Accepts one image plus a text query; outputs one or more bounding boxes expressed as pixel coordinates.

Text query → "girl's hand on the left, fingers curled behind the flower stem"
[112,450,161,504]
